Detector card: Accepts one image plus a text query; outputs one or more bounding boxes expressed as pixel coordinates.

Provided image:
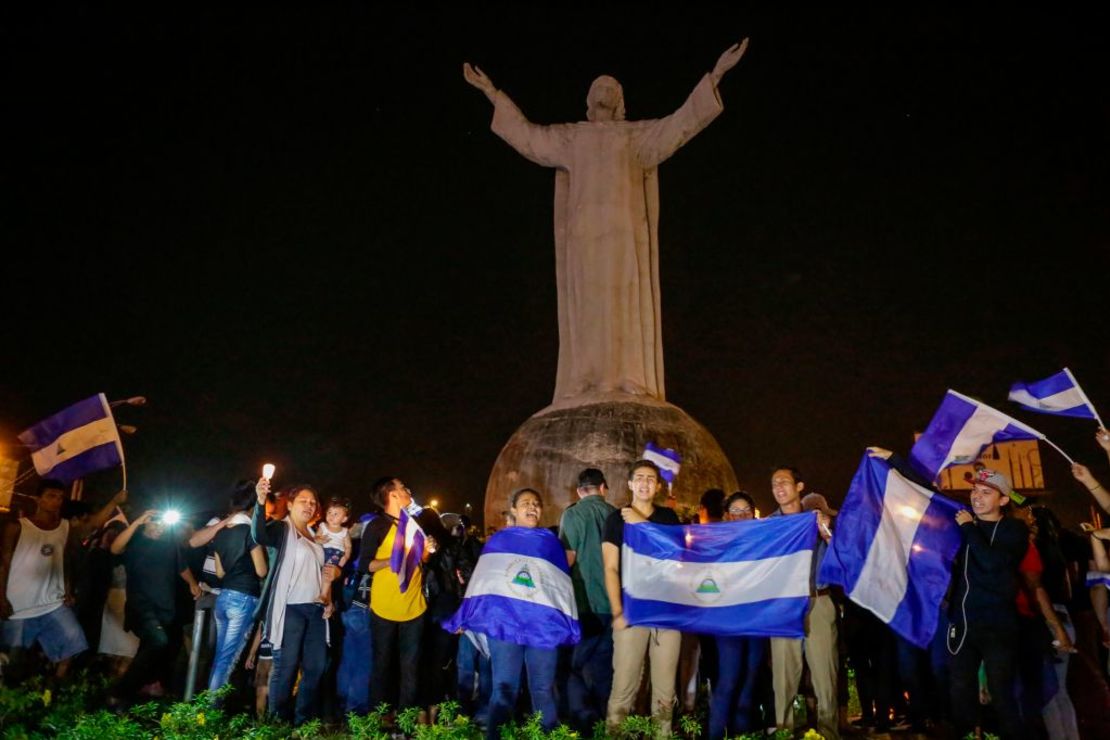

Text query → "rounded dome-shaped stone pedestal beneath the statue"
[485,394,737,527]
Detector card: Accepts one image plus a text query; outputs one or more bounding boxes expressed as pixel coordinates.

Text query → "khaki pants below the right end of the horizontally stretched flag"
[770,595,840,740]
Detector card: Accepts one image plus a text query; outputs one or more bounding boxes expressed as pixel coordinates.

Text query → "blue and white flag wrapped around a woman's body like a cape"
[443,527,582,649]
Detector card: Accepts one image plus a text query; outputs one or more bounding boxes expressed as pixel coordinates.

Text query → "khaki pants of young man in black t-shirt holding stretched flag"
[605,627,683,737]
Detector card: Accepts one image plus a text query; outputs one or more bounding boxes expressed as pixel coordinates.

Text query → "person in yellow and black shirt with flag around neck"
[359,477,435,710]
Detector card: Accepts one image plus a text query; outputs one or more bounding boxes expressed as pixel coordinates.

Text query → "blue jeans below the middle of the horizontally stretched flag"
[709,637,767,740]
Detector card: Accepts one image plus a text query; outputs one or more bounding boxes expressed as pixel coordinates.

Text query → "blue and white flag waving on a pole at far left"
[19,393,123,484]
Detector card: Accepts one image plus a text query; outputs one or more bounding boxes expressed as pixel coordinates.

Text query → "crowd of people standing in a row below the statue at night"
[0,429,1110,739]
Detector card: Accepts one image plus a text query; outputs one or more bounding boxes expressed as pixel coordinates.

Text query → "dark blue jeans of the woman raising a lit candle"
[270,604,327,726]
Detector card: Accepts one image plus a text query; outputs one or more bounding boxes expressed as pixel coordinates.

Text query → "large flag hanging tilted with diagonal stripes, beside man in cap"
[817,455,962,648]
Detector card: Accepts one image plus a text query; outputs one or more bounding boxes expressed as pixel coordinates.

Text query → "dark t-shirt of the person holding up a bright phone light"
[121,528,185,622]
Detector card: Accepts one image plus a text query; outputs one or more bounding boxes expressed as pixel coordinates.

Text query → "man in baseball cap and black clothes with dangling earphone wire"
[948,467,1032,738]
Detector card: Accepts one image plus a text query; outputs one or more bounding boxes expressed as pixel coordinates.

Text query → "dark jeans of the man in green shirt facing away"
[566,614,613,737]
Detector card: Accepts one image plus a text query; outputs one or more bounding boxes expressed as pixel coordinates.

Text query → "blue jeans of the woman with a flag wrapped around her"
[486,637,558,740]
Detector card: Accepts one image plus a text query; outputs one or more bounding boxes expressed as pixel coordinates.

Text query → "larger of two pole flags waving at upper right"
[909,391,1045,480]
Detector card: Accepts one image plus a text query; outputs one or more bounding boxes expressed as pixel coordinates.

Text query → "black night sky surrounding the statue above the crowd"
[0,3,1110,525]
